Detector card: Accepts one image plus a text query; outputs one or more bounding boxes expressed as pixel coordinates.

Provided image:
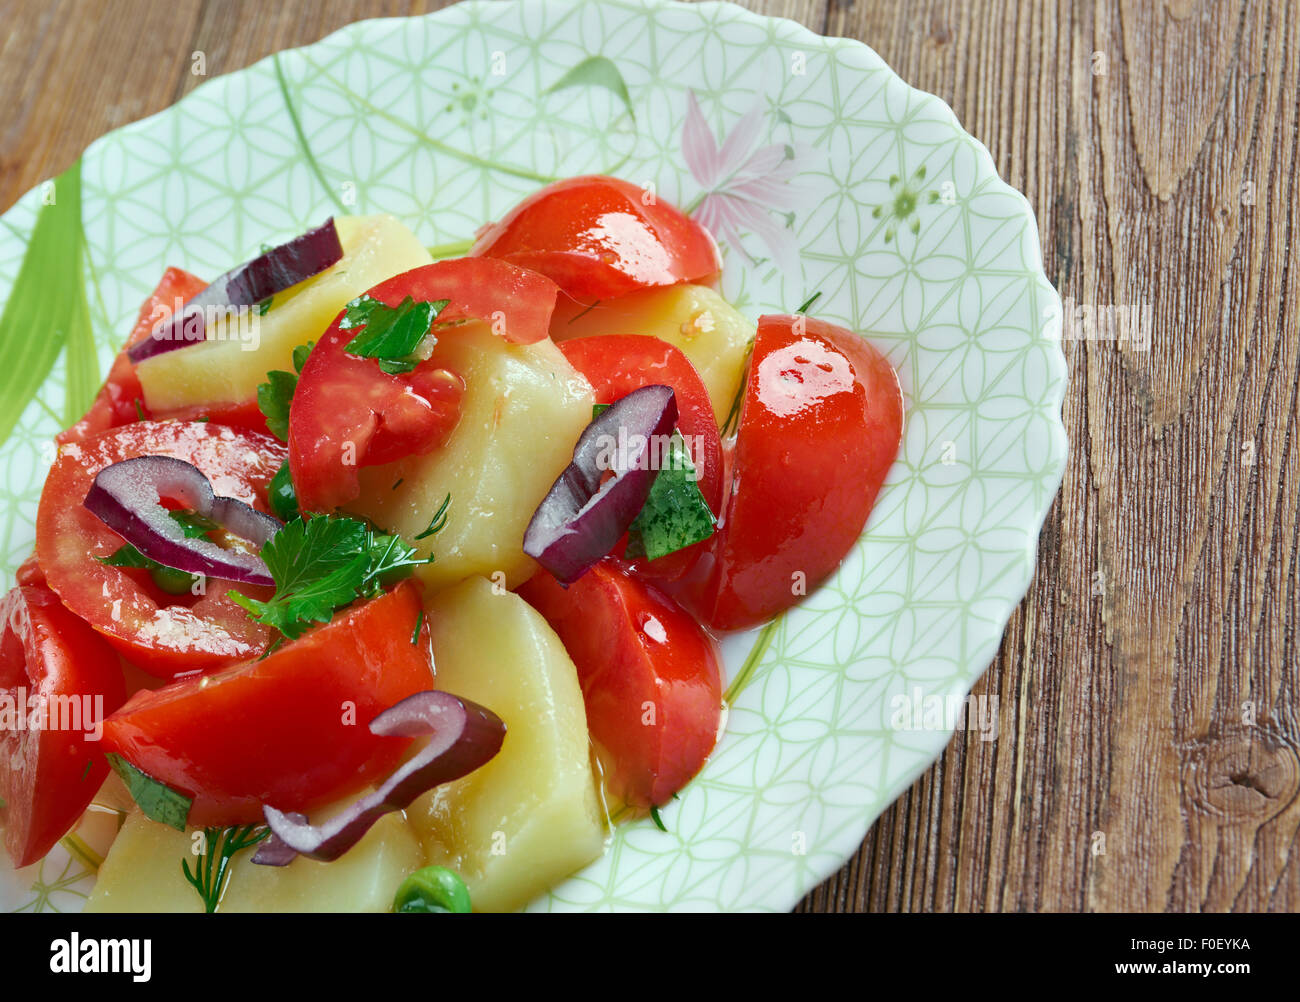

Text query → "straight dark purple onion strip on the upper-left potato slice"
[126,217,343,363]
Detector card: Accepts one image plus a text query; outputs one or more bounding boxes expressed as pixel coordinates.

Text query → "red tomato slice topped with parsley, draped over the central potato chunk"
[289,257,559,511]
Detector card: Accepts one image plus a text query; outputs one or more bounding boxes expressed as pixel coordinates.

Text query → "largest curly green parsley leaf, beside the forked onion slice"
[229,515,432,639]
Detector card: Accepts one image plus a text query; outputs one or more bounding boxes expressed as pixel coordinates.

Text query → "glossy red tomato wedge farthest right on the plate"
[679,316,904,630]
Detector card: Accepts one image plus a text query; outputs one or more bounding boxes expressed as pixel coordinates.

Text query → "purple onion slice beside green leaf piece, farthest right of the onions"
[524,385,677,585]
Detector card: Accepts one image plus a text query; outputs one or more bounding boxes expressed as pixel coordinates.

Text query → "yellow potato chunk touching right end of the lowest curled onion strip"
[407,577,605,911]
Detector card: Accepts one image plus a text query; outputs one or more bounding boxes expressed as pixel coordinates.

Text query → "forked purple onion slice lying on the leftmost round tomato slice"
[85,456,282,585]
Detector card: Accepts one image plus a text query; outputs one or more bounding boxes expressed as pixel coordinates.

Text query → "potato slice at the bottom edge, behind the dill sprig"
[86,811,423,912]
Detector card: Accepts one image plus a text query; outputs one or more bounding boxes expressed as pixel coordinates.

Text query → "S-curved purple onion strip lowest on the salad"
[252,690,506,867]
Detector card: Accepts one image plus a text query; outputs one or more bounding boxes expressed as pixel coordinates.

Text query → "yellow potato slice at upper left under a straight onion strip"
[137,216,433,411]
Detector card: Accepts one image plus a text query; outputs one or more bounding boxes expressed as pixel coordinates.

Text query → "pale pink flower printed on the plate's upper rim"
[681,91,805,270]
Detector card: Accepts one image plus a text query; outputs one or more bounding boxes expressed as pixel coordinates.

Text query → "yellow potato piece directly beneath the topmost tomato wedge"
[551,285,754,425]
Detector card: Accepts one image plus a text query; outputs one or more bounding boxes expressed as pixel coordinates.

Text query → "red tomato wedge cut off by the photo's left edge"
[0,587,126,867]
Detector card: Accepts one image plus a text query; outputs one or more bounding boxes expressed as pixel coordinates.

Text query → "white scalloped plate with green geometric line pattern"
[0,0,1066,910]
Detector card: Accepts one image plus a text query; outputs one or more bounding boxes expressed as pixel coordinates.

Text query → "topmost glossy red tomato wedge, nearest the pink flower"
[469,174,722,304]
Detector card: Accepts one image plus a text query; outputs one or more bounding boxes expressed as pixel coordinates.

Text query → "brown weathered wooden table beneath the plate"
[0,0,1300,911]
